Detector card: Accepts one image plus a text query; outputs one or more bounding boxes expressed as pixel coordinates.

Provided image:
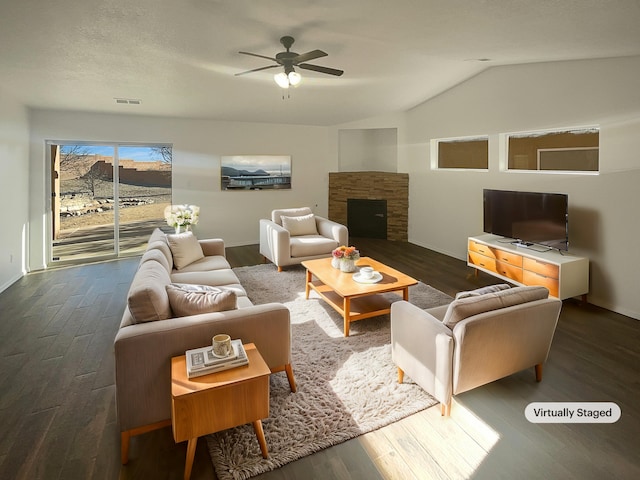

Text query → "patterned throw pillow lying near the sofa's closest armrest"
[167,283,237,317]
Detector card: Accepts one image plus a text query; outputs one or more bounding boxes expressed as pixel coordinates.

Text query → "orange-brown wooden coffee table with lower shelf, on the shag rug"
[302,257,418,337]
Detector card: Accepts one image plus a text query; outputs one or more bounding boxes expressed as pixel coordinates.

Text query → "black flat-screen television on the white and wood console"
[483,189,569,250]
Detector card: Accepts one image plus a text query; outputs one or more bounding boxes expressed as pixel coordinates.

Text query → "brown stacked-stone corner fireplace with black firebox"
[329,172,409,242]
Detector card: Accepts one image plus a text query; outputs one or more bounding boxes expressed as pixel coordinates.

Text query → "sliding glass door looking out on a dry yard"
[49,142,171,265]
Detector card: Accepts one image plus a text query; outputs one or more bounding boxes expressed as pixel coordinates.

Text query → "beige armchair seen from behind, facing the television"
[391,285,562,415]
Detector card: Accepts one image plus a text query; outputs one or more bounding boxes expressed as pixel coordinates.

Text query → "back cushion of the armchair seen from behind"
[442,286,549,329]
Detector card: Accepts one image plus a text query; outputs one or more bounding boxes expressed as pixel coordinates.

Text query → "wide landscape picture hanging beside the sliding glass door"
[220,155,291,190]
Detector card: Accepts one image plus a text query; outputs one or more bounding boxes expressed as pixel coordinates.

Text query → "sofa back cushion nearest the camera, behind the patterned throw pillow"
[127,260,172,323]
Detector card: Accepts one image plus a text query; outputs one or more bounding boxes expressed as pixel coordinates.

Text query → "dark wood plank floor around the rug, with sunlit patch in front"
[0,239,640,480]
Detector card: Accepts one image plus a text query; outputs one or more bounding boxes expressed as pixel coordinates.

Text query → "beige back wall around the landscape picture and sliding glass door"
[30,110,337,269]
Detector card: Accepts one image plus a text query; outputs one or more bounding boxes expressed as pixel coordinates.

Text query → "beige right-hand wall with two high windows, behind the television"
[399,57,640,318]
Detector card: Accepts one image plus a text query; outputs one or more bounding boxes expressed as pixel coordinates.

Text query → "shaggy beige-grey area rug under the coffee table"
[206,264,451,480]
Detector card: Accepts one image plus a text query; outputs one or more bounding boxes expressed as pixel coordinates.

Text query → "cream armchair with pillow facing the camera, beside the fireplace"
[260,207,349,272]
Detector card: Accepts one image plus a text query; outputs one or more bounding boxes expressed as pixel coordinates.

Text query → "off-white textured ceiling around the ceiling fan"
[0,0,640,125]
